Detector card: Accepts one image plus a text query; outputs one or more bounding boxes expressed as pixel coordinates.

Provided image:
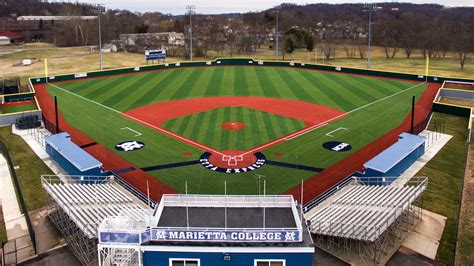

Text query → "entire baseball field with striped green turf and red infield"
[35,66,433,197]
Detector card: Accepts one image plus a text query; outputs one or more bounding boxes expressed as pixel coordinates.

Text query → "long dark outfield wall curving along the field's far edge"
[31,58,474,84]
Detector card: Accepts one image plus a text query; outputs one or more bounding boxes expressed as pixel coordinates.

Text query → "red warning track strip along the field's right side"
[285,83,441,203]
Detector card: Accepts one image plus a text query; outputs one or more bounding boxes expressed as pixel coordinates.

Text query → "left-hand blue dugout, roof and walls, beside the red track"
[45,132,102,176]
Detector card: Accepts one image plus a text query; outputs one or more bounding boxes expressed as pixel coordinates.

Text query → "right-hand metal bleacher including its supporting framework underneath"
[305,177,428,264]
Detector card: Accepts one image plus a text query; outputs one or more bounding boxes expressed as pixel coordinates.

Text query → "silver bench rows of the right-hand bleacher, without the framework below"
[306,178,426,242]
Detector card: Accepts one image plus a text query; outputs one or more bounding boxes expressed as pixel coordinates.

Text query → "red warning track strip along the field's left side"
[35,84,176,200]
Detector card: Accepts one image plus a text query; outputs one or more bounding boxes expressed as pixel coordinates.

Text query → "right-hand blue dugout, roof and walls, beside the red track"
[362,133,425,182]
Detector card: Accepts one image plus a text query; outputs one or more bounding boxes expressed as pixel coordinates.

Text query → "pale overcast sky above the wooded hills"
[75,0,474,15]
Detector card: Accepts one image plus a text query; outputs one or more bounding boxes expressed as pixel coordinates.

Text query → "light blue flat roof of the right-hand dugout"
[364,133,425,173]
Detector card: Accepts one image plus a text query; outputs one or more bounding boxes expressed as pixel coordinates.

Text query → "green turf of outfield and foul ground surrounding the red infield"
[47,66,426,194]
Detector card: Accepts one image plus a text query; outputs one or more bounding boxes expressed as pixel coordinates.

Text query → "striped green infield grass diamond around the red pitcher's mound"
[162,107,305,150]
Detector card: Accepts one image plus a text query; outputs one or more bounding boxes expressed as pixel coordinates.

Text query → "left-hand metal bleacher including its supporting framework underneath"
[41,175,153,265]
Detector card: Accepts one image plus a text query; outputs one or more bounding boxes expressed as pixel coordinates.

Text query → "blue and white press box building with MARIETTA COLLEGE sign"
[98,195,314,266]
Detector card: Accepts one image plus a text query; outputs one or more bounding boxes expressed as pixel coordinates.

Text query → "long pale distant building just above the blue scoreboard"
[119,32,184,48]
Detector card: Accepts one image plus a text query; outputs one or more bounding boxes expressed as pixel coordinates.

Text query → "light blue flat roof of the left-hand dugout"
[45,132,102,172]
